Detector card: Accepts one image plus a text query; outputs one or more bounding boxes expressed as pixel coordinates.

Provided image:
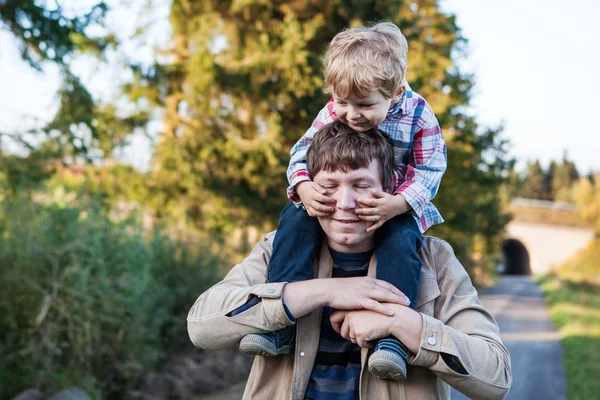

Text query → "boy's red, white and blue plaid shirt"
[287,85,447,233]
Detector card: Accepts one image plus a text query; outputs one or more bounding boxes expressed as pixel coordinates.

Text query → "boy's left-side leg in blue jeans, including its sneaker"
[240,203,323,356]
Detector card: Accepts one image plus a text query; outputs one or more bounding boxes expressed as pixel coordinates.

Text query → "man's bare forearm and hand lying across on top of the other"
[283,276,410,319]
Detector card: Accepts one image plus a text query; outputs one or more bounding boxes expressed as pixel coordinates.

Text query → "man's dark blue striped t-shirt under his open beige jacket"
[305,249,373,400]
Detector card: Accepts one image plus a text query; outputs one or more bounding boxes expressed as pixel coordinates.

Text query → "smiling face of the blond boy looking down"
[333,89,404,132]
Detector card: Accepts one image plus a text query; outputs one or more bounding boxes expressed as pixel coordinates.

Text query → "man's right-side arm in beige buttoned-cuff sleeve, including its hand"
[331,238,512,399]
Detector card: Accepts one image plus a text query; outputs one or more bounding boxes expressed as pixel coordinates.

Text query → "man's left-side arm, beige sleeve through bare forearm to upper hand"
[187,233,408,350]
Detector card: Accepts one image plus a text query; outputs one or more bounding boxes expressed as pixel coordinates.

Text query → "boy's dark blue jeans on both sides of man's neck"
[269,203,423,309]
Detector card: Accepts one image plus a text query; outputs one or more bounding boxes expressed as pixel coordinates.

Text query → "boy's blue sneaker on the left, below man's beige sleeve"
[240,325,296,357]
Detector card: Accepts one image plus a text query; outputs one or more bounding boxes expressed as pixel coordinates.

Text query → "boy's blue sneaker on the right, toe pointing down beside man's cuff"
[368,337,408,381]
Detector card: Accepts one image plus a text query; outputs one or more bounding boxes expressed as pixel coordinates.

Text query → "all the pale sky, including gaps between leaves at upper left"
[0,0,600,173]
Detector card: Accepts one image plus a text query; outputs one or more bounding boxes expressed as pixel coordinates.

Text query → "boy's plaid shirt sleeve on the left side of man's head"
[287,98,337,204]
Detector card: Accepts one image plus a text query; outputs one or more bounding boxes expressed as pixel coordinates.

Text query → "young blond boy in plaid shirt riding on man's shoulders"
[240,22,447,380]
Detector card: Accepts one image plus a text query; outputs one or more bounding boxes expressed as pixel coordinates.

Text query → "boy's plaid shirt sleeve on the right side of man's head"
[394,100,448,218]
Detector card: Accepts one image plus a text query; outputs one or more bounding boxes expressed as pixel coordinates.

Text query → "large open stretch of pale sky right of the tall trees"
[440,0,600,173]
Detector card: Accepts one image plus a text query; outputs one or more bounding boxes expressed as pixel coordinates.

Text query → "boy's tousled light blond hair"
[323,22,408,99]
